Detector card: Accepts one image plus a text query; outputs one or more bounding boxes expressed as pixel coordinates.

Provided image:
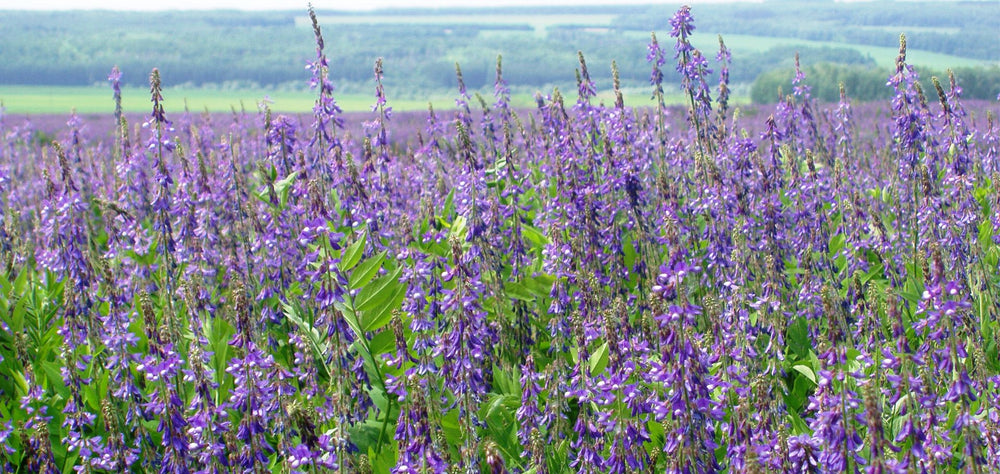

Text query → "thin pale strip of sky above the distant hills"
[0,0,746,10]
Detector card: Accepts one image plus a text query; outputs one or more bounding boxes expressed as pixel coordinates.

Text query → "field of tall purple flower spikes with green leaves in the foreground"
[0,7,1000,474]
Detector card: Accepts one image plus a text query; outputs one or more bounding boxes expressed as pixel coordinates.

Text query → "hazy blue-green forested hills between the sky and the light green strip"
[0,1,1000,102]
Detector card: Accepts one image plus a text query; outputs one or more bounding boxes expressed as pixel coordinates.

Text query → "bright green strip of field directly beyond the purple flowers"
[0,85,724,115]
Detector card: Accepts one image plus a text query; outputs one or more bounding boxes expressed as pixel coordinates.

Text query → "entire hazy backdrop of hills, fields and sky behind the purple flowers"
[0,0,1000,113]
